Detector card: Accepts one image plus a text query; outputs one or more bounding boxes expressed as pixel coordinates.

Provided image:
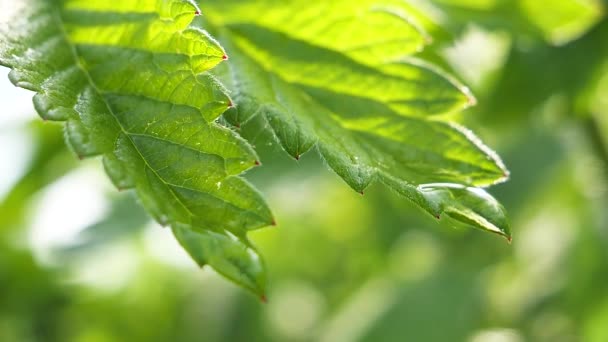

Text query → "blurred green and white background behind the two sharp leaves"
[0,0,608,342]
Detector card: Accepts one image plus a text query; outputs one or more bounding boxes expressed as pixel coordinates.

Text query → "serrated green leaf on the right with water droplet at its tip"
[201,0,510,238]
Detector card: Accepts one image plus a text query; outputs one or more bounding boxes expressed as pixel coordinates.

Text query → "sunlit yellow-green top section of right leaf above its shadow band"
[201,0,430,64]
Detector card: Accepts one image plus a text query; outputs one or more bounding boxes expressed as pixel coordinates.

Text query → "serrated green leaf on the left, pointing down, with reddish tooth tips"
[0,0,273,295]
